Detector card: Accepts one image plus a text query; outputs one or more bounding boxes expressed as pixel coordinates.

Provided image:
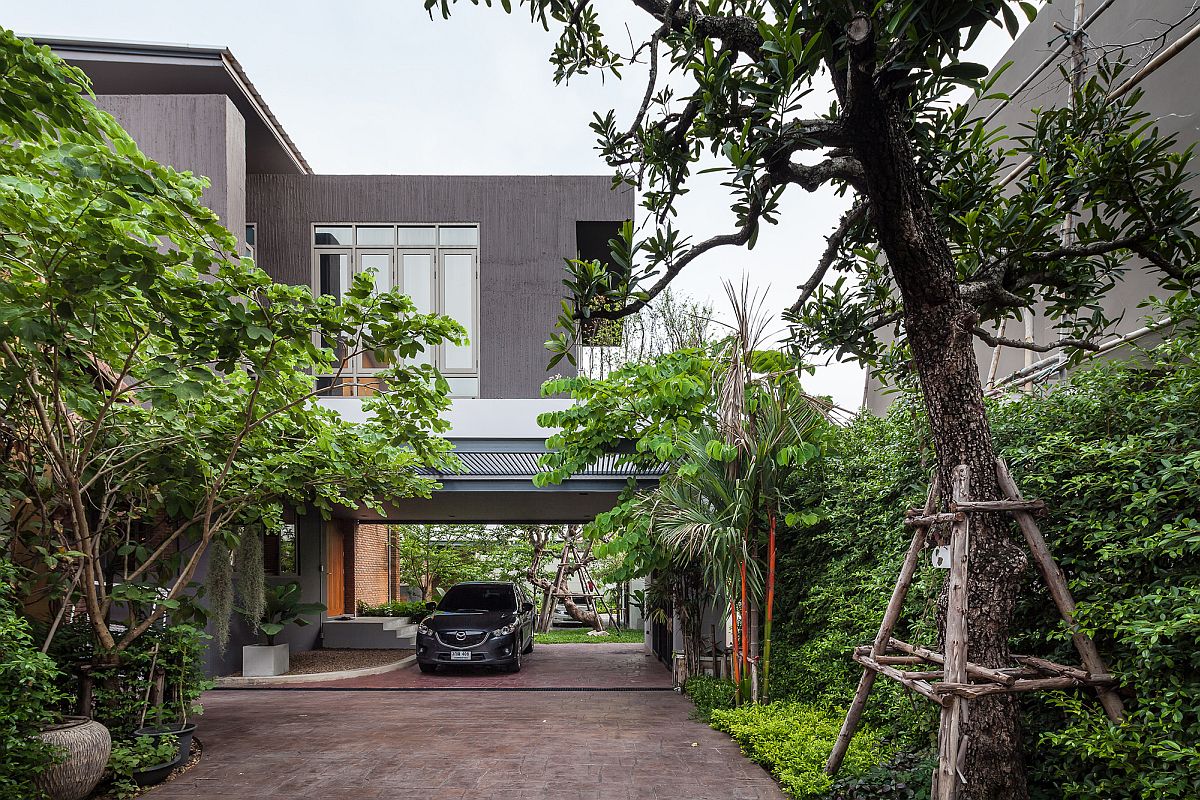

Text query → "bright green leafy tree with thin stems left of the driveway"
[0,30,463,661]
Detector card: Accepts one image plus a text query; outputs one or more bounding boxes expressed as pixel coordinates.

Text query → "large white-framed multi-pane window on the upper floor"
[312,223,479,397]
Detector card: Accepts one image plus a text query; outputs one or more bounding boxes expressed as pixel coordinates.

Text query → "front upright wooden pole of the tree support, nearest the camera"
[932,464,971,800]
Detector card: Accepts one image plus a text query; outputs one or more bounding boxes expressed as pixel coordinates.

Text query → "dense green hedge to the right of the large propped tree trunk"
[995,329,1200,800]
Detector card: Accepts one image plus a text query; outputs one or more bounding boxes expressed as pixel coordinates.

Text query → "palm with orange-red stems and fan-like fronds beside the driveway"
[647,283,824,699]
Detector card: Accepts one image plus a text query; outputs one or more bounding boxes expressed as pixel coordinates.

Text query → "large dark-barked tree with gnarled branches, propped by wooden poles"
[436,0,1196,798]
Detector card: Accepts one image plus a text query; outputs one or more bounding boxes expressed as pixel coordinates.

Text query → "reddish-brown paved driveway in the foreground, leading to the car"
[148,645,784,800]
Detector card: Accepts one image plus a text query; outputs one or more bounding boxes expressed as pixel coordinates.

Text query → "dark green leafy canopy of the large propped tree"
[425,0,1200,374]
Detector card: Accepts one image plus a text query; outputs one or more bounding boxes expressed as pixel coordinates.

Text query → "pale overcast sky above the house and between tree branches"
[7,0,1009,409]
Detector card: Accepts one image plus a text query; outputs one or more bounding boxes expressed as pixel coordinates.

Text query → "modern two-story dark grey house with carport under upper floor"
[40,38,648,674]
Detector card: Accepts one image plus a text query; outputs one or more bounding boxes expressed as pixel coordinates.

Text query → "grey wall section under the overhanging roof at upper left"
[96,95,246,255]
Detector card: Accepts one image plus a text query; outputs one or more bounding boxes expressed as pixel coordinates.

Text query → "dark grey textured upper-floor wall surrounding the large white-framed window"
[247,175,634,398]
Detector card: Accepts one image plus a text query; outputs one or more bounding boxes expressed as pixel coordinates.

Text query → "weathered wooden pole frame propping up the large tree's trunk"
[826,458,1124,800]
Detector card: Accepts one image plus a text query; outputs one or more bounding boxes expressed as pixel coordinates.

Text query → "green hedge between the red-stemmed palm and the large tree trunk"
[772,401,944,747]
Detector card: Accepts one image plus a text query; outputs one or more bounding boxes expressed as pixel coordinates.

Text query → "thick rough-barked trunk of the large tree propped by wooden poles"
[853,98,1028,800]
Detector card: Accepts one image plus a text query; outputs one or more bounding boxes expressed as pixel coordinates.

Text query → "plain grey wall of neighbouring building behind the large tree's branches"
[865,0,1200,414]
